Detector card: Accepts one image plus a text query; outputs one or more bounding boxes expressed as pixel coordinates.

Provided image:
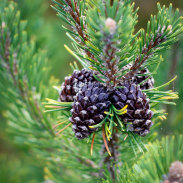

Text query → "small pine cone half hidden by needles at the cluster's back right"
[122,64,154,90]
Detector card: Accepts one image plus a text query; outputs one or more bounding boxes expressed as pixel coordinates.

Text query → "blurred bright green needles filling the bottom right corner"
[133,135,183,183]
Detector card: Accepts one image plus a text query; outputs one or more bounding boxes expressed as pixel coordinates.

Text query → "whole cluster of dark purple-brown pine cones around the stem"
[60,69,154,139]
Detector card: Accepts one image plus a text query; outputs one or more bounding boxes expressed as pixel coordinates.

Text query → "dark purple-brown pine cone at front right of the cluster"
[112,83,153,136]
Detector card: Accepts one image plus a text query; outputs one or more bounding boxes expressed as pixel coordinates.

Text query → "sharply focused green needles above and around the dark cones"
[49,0,183,147]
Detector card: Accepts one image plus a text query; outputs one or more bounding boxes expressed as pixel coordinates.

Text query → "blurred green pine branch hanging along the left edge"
[0,4,54,140]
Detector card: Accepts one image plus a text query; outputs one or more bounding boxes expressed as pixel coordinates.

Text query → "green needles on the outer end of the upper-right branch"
[132,3,183,70]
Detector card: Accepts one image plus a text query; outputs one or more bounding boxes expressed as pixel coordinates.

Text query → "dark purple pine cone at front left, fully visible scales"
[70,82,111,139]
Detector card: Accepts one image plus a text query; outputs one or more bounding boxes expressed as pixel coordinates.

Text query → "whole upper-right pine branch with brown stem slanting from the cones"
[123,3,183,80]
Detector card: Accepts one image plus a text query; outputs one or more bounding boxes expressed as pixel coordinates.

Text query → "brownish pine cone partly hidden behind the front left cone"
[60,69,96,102]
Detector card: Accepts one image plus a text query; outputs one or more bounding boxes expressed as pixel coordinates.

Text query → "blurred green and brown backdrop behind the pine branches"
[0,0,183,183]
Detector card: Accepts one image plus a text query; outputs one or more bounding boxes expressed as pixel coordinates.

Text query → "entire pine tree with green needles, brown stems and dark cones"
[0,0,183,183]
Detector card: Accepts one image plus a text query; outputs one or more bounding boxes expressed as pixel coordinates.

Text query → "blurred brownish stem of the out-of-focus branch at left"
[0,23,55,136]
